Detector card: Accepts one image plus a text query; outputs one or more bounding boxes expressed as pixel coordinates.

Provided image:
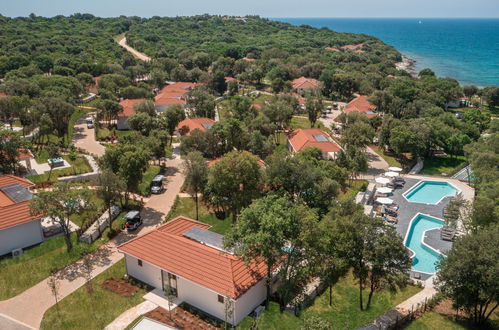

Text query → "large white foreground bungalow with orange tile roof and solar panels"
[118,217,266,325]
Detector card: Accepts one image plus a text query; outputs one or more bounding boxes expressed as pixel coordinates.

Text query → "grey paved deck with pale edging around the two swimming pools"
[382,175,474,280]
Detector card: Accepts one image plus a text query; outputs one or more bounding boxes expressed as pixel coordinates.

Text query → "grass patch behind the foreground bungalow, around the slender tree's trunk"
[166,197,232,235]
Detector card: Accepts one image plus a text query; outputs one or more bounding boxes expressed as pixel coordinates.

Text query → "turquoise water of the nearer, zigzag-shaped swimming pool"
[404,214,444,273]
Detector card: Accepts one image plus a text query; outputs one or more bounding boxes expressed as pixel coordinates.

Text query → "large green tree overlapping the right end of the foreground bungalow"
[225,195,317,309]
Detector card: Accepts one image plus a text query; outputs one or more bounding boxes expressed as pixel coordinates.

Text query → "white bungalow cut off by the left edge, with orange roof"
[0,175,43,255]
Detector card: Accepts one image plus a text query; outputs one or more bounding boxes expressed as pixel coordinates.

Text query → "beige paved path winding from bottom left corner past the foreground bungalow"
[0,153,184,330]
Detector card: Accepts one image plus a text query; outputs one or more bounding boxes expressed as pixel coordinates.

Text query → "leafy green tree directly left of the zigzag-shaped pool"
[332,212,411,311]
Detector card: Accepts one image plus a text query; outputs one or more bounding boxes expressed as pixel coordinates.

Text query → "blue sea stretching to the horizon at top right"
[277,18,499,86]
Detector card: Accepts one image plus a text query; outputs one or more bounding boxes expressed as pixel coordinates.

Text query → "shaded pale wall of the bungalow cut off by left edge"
[0,219,43,255]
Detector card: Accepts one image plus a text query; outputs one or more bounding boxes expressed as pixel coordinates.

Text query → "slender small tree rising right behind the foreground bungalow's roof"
[184,151,208,220]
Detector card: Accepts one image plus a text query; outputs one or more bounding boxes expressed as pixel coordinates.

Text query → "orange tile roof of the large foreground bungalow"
[118,217,266,299]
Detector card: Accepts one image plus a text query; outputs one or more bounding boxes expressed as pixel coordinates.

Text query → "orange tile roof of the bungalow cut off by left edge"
[0,174,39,230]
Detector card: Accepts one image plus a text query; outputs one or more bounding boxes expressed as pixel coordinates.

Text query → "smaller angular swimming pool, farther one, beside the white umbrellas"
[404,181,459,204]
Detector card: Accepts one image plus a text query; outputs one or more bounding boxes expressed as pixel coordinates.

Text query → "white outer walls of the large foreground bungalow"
[125,254,266,324]
